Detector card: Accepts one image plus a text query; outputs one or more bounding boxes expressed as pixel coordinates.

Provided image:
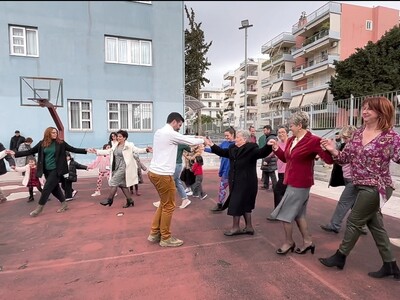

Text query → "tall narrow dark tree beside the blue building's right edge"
[185,5,212,99]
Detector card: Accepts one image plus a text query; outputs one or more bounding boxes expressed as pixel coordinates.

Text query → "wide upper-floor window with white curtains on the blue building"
[105,36,152,66]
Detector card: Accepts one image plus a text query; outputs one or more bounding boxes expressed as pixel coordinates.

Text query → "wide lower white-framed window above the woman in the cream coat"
[108,101,153,131]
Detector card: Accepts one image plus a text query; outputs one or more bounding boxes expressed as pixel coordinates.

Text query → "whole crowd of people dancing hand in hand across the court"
[0,97,400,280]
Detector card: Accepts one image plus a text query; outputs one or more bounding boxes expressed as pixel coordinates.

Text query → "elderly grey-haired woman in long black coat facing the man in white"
[206,130,272,236]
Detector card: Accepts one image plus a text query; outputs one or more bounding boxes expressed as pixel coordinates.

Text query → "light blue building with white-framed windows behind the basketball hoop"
[0,1,184,147]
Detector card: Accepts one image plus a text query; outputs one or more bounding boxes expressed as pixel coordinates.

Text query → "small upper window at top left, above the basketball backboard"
[9,25,39,57]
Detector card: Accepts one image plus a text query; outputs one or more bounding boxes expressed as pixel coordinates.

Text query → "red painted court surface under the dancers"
[0,170,400,300]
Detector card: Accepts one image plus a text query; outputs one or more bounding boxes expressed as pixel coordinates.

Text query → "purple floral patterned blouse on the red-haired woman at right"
[334,126,400,207]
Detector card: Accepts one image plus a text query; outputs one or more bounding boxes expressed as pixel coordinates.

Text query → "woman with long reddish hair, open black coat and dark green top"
[14,127,94,217]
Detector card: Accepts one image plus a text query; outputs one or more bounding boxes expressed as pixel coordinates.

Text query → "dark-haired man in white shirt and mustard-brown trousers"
[147,112,204,247]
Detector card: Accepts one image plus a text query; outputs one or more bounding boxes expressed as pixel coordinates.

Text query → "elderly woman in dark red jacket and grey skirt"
[268,111,333,255]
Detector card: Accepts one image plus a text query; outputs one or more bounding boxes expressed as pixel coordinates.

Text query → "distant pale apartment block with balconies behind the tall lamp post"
[223,58,268,128]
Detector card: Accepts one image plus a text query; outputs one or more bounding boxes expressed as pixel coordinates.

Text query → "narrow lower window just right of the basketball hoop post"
[68,100,93,131]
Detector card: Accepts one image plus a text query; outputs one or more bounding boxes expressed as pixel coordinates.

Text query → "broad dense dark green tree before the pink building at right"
[329,26,400,100]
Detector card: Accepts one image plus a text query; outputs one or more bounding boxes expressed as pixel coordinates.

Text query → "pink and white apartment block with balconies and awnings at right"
[224,2,399,129]
